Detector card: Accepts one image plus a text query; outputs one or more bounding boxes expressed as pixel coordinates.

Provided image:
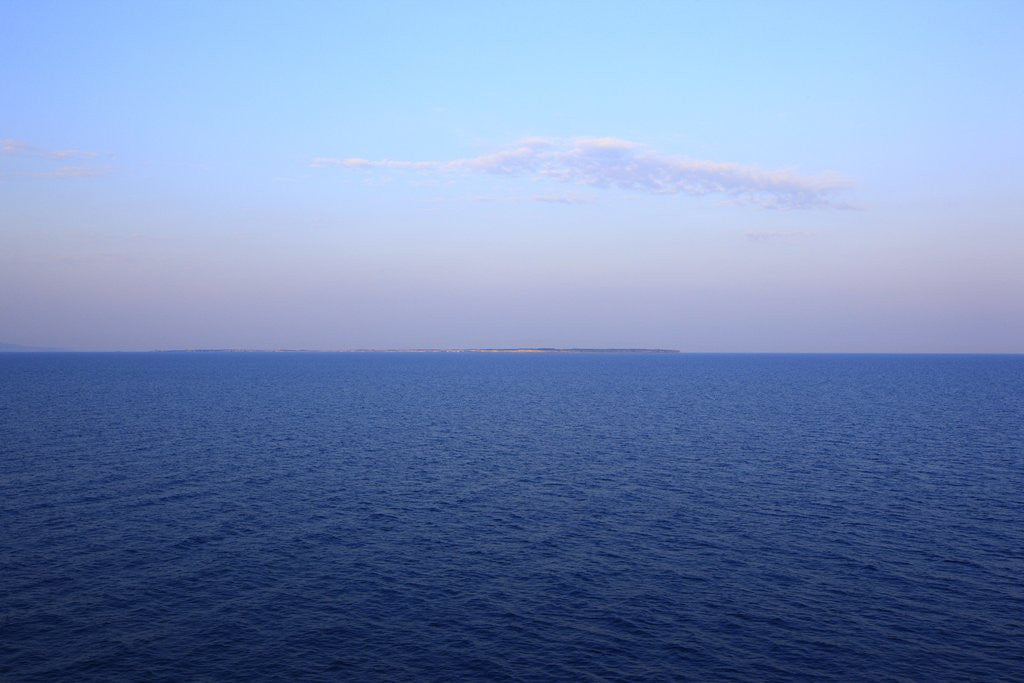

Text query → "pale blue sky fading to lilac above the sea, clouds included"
[0,0,1024,352]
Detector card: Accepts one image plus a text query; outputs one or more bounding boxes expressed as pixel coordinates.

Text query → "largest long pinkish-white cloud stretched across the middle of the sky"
[311,137,850,209]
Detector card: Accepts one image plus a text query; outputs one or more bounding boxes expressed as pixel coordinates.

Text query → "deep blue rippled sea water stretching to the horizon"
[0,353,1024,681]
